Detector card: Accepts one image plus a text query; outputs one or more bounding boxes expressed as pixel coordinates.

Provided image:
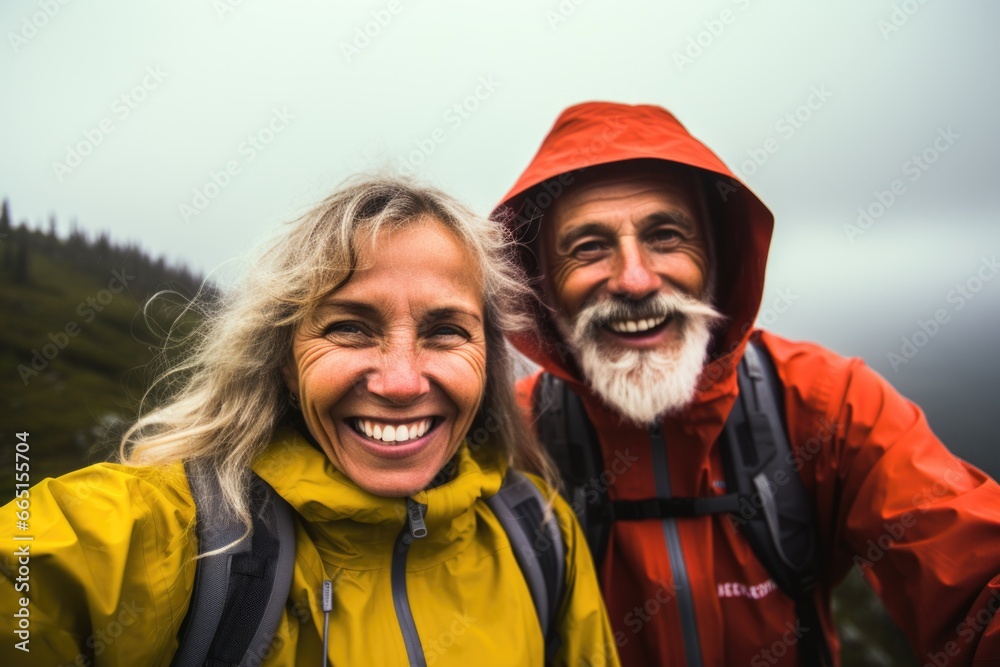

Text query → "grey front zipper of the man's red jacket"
[649,421,702,667]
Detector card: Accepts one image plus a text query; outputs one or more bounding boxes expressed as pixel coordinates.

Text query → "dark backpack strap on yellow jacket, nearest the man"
[486,469,566,663]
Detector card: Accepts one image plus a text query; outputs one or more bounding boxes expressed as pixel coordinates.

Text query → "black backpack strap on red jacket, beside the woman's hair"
[534,373,613,575]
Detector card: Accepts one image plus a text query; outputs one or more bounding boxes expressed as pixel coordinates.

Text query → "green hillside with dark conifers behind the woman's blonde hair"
[0,206,198,497]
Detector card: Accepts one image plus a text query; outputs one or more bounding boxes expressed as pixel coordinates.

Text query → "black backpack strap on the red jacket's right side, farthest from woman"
[722,343,833,665]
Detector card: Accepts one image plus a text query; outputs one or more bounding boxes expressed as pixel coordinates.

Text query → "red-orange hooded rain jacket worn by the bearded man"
[494,102,1000,667]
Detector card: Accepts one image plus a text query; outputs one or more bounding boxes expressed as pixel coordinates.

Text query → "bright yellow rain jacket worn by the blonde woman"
[0,434,619,667]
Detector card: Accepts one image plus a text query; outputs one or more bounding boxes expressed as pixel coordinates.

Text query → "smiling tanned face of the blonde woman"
[285,218,486,496]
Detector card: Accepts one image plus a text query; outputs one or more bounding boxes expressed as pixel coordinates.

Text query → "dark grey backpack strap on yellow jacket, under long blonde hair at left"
[171,462,295,667]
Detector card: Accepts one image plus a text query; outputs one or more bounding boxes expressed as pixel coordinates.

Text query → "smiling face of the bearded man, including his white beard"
[542,161,718,422]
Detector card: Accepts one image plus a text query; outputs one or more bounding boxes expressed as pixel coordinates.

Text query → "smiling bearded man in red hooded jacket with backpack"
[494,102,1000,666]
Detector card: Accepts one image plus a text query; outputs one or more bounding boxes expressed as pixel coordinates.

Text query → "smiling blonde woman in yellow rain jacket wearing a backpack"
[0,178,617,667]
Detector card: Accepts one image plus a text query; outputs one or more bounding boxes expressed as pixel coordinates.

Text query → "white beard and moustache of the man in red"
[555,294,722,426]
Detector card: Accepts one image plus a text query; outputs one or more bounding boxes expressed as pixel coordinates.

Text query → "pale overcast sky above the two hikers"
[0,0,1000,478]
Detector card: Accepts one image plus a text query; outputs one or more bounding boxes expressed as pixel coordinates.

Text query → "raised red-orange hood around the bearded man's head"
[493,102,774,402]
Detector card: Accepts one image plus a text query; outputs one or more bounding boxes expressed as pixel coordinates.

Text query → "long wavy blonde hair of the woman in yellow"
[119,177,555,534]
